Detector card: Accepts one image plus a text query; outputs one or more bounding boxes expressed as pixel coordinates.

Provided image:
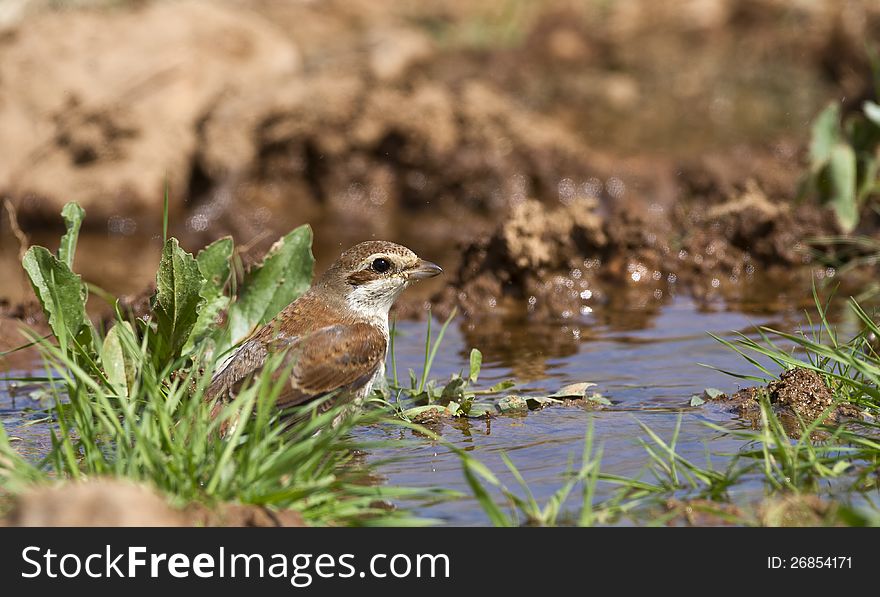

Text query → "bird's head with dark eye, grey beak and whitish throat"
[318,241,443,318]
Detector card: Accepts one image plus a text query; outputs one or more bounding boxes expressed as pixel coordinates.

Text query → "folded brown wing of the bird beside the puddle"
[206,323,387,408]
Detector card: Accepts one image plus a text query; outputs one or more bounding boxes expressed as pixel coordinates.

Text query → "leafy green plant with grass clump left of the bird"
[0,198,443,524]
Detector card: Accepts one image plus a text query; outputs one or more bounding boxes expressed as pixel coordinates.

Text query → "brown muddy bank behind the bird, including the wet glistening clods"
[0,0,880,320]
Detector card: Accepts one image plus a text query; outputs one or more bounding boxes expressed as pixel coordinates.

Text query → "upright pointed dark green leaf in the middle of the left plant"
[153,237,205,364]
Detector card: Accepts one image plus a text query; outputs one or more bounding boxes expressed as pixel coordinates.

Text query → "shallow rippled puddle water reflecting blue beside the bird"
[0,298,868,525]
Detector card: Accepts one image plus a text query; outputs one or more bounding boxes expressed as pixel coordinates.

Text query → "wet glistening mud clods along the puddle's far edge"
[433,172,837,320]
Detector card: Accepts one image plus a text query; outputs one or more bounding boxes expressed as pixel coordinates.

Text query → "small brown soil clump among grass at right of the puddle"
[707,367,859,430]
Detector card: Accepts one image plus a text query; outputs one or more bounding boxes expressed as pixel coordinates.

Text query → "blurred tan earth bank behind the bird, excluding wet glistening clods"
[0,0,880,307]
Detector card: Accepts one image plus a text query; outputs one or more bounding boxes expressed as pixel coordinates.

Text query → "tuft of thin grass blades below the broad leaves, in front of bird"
[0,334,426,524]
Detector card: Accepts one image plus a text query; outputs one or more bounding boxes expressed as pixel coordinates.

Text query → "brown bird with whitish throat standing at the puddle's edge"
[205,240,443,426]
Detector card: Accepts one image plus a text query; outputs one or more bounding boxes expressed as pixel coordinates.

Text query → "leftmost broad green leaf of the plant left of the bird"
[22,246,89,348]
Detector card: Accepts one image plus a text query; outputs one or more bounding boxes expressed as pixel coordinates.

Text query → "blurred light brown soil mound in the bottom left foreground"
[0,479,304,527]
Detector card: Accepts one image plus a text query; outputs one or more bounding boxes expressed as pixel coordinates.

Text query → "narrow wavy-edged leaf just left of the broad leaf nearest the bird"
[182,236,233,354]
